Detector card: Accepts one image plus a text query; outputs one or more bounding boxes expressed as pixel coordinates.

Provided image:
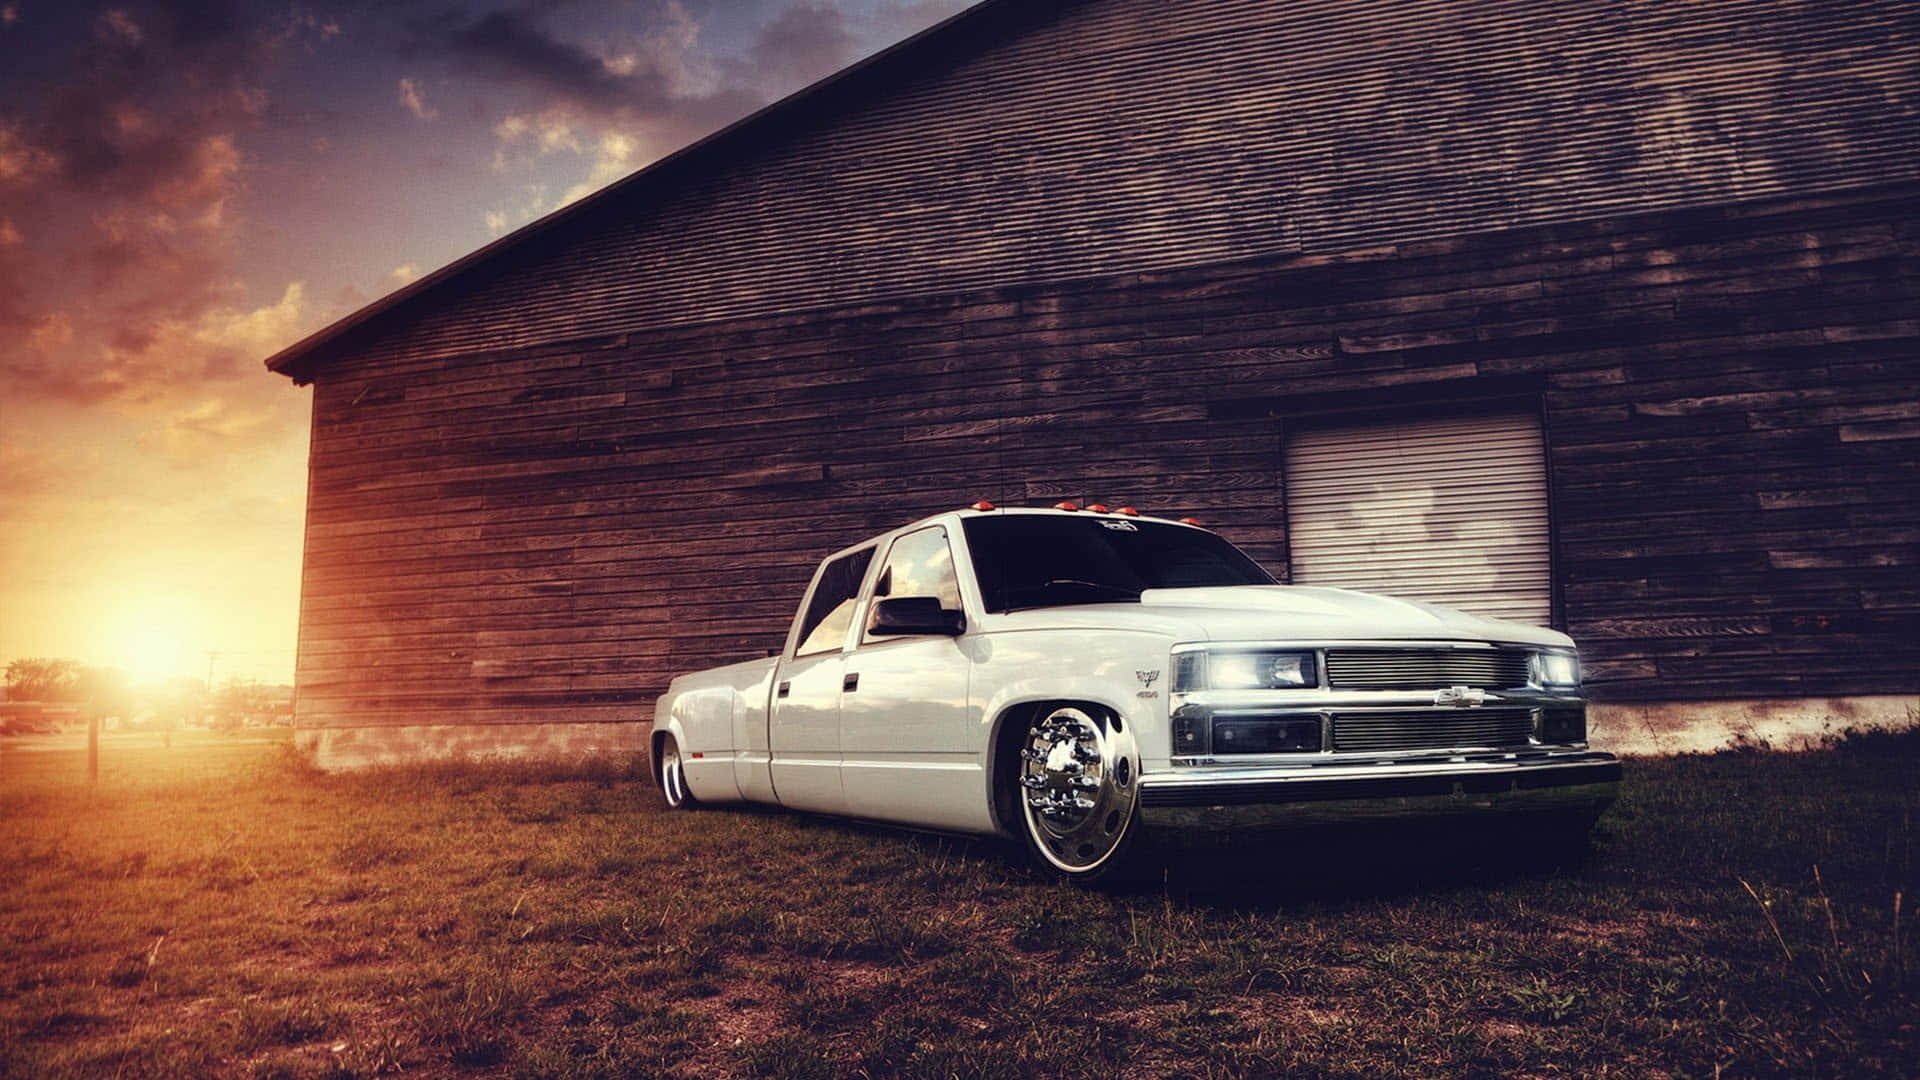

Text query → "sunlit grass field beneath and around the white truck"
[0,732,1920,1076]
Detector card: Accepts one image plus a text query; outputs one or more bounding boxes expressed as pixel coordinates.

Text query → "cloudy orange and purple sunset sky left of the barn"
[0,0,968,682]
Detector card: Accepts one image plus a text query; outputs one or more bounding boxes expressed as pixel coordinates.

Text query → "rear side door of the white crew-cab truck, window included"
[766,548,874,813]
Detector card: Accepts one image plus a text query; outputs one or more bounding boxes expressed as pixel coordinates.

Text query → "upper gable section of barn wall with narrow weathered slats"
[291,0,1920,374]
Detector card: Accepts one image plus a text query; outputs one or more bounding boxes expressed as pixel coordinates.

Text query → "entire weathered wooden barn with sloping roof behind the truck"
[267,0,1920,765]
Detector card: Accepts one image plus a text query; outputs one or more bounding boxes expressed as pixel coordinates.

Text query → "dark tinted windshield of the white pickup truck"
[964,513,1275,611]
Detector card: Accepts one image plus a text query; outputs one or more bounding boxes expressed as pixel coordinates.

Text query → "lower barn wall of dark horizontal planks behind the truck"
[298,184,1920,749]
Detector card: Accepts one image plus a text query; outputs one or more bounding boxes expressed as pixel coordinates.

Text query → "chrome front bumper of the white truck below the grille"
[1140,749,1620,832]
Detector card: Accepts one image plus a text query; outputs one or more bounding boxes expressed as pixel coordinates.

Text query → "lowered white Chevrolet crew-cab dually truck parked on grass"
[651,503,1620,880]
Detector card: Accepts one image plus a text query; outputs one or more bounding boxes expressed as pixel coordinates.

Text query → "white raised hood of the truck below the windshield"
[1010,584,1572,646]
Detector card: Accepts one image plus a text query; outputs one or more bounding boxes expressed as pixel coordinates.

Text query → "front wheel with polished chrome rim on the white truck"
[1010,705,1140,884]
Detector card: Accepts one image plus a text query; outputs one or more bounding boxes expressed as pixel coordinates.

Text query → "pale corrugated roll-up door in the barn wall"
[1286,413,1551,623]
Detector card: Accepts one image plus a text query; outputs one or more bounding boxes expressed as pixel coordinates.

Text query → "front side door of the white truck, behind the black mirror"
[841,525,993,832]
